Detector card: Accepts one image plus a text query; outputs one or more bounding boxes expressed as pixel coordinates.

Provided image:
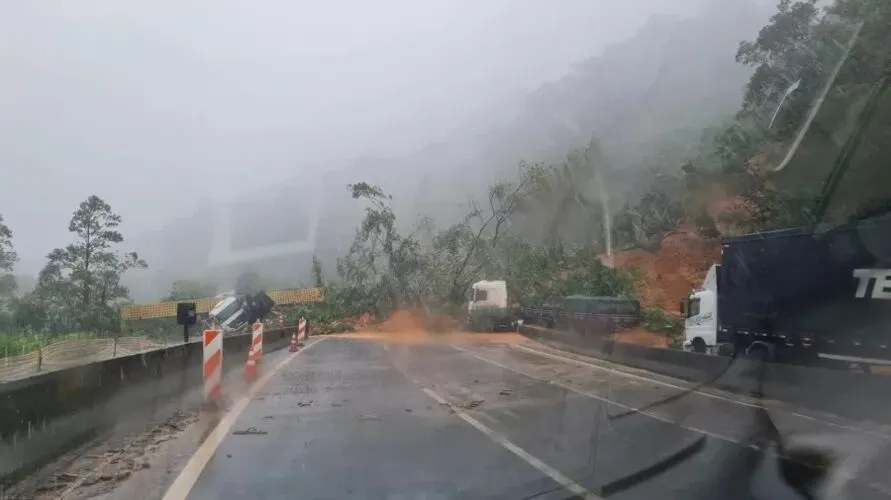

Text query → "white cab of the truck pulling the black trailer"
[681,264,721,354]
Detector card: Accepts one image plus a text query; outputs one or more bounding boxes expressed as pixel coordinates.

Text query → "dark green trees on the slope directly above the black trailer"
[716,0,891,231]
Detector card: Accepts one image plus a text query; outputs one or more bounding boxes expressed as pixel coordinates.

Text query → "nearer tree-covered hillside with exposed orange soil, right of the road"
[304,0,891,342]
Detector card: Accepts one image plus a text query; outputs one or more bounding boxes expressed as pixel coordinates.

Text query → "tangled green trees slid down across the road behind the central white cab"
[328,156,634,324]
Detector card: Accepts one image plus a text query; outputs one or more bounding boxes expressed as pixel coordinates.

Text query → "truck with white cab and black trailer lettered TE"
[684,209,891,367]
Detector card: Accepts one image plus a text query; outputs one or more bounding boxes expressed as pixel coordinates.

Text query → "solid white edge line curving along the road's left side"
[163,337,325,500]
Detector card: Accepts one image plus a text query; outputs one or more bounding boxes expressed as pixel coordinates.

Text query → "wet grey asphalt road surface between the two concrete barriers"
[188,338,891,499]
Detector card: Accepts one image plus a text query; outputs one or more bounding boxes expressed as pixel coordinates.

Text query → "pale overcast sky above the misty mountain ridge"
[0,0,691,272]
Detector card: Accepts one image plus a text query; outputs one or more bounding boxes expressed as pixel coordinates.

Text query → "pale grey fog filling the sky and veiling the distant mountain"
[0,0,773,301]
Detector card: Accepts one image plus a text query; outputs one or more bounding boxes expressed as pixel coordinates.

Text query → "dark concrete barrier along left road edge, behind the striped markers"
[0,327,293,487]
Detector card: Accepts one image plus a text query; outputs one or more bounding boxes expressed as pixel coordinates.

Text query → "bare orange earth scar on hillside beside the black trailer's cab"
[613,230,721,314]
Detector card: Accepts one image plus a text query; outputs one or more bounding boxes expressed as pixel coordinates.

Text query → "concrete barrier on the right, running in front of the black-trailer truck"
[520,325,891,423]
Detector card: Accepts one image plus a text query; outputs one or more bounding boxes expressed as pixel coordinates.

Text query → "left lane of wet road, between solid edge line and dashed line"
[177,339,567,499]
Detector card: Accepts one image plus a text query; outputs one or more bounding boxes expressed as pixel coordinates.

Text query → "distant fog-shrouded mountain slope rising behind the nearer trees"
[116,0,770,300]
